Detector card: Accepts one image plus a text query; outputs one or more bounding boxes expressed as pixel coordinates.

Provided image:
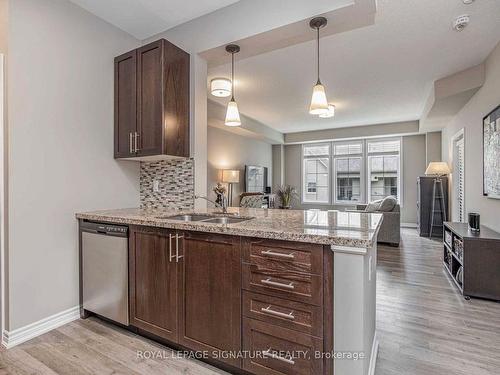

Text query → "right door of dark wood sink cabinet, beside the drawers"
[178,232,241,367]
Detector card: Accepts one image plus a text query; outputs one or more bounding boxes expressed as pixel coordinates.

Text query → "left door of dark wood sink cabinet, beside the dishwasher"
[129,227,179,341]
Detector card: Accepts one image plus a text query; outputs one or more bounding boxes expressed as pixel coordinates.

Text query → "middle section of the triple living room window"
[334,142,363,203]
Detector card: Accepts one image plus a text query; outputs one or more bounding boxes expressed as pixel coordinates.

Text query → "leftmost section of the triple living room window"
[302,144,330,203]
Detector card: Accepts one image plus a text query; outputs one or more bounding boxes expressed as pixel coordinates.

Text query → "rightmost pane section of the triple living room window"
[367,139,401,202]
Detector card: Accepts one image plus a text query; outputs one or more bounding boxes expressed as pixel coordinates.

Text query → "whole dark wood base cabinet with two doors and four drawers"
[129,227,333,375]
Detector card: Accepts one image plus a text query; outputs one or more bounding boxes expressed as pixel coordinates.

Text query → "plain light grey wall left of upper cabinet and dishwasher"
[6,0,139,330]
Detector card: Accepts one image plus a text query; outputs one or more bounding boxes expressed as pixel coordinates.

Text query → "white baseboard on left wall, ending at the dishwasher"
[2,306,80,349]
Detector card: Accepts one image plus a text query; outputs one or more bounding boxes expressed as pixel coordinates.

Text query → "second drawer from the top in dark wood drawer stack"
[243,263,323,306]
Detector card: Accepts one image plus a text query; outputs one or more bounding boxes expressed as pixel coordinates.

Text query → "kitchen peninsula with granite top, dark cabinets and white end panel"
[77,208,382,375]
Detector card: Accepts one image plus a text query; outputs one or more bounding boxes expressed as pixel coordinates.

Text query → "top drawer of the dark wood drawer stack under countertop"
[243,239,323,275]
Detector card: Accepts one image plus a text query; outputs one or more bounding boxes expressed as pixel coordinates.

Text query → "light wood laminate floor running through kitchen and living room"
[0,229,500,375]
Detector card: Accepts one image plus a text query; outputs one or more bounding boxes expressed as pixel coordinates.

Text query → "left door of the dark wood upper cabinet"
[114,50,137,158]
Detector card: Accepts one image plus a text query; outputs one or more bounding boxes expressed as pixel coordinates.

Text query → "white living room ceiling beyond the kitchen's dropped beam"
[208,0,500,132]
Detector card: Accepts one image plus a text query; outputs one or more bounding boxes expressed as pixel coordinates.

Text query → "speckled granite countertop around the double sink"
[76,207,382,247]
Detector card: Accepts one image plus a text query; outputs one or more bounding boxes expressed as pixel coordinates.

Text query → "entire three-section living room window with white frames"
[302,138,401,205]
